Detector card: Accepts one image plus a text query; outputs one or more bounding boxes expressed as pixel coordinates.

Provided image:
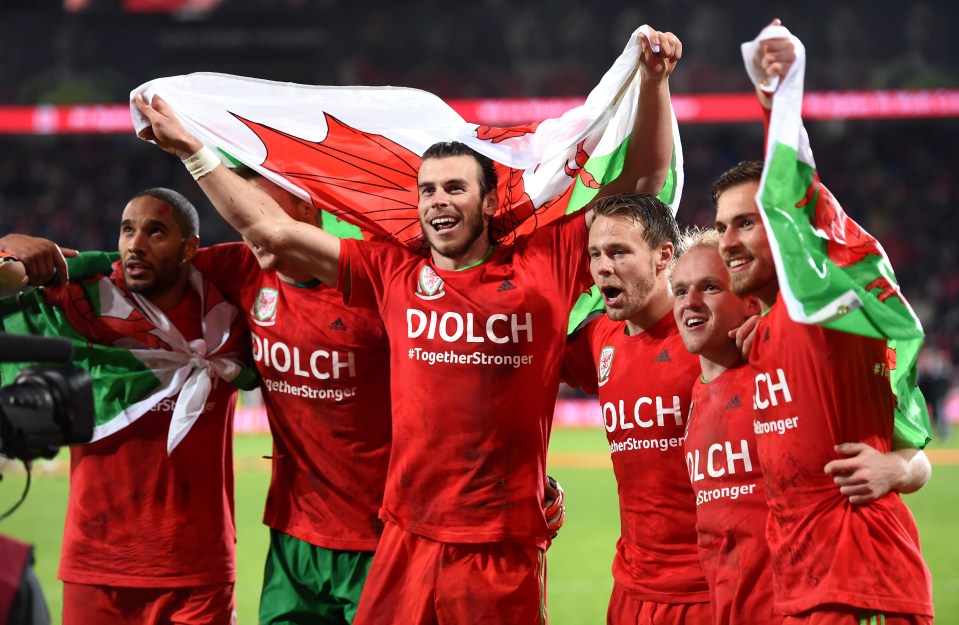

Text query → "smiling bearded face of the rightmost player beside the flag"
[716,182,779,307]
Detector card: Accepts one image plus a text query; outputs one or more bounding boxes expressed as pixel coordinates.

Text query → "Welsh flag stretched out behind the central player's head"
[130,26,683,328]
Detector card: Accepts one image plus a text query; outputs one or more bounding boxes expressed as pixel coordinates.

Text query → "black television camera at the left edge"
[0,332,94,461]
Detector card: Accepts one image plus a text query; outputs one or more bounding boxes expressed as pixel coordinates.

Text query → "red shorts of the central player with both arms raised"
[353,522,546,625]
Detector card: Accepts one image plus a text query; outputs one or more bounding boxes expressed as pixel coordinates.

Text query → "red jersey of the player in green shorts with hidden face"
[193,243,390,551]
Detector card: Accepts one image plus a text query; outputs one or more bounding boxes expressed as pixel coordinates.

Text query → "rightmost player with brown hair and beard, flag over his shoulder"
[712,161,933,625]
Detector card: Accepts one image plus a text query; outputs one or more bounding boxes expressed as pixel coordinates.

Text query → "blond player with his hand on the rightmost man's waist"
[669,229,929,625]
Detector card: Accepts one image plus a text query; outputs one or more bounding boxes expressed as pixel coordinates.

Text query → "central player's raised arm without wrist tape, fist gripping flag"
[586,29,683,229]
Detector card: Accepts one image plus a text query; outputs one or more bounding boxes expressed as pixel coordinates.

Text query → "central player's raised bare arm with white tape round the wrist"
[134,95,340,286]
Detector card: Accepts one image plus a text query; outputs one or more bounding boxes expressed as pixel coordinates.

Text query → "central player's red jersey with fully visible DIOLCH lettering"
[338,213,590,548]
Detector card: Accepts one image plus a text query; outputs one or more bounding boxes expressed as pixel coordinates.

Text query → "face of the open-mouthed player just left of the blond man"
[589,215,673,333]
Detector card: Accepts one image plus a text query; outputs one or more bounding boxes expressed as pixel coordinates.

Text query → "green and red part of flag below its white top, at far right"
[760,137,931,449]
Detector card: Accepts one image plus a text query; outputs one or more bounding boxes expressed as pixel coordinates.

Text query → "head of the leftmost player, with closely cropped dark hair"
[118,195,199,310]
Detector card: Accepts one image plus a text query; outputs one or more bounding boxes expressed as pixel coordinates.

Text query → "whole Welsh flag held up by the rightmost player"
[742,26,930,448]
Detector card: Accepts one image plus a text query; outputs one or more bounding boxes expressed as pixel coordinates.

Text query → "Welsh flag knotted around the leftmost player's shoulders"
[0,254,256,453]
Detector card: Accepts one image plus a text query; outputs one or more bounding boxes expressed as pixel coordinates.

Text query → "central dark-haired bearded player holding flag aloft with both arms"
[135,31,681,624]
